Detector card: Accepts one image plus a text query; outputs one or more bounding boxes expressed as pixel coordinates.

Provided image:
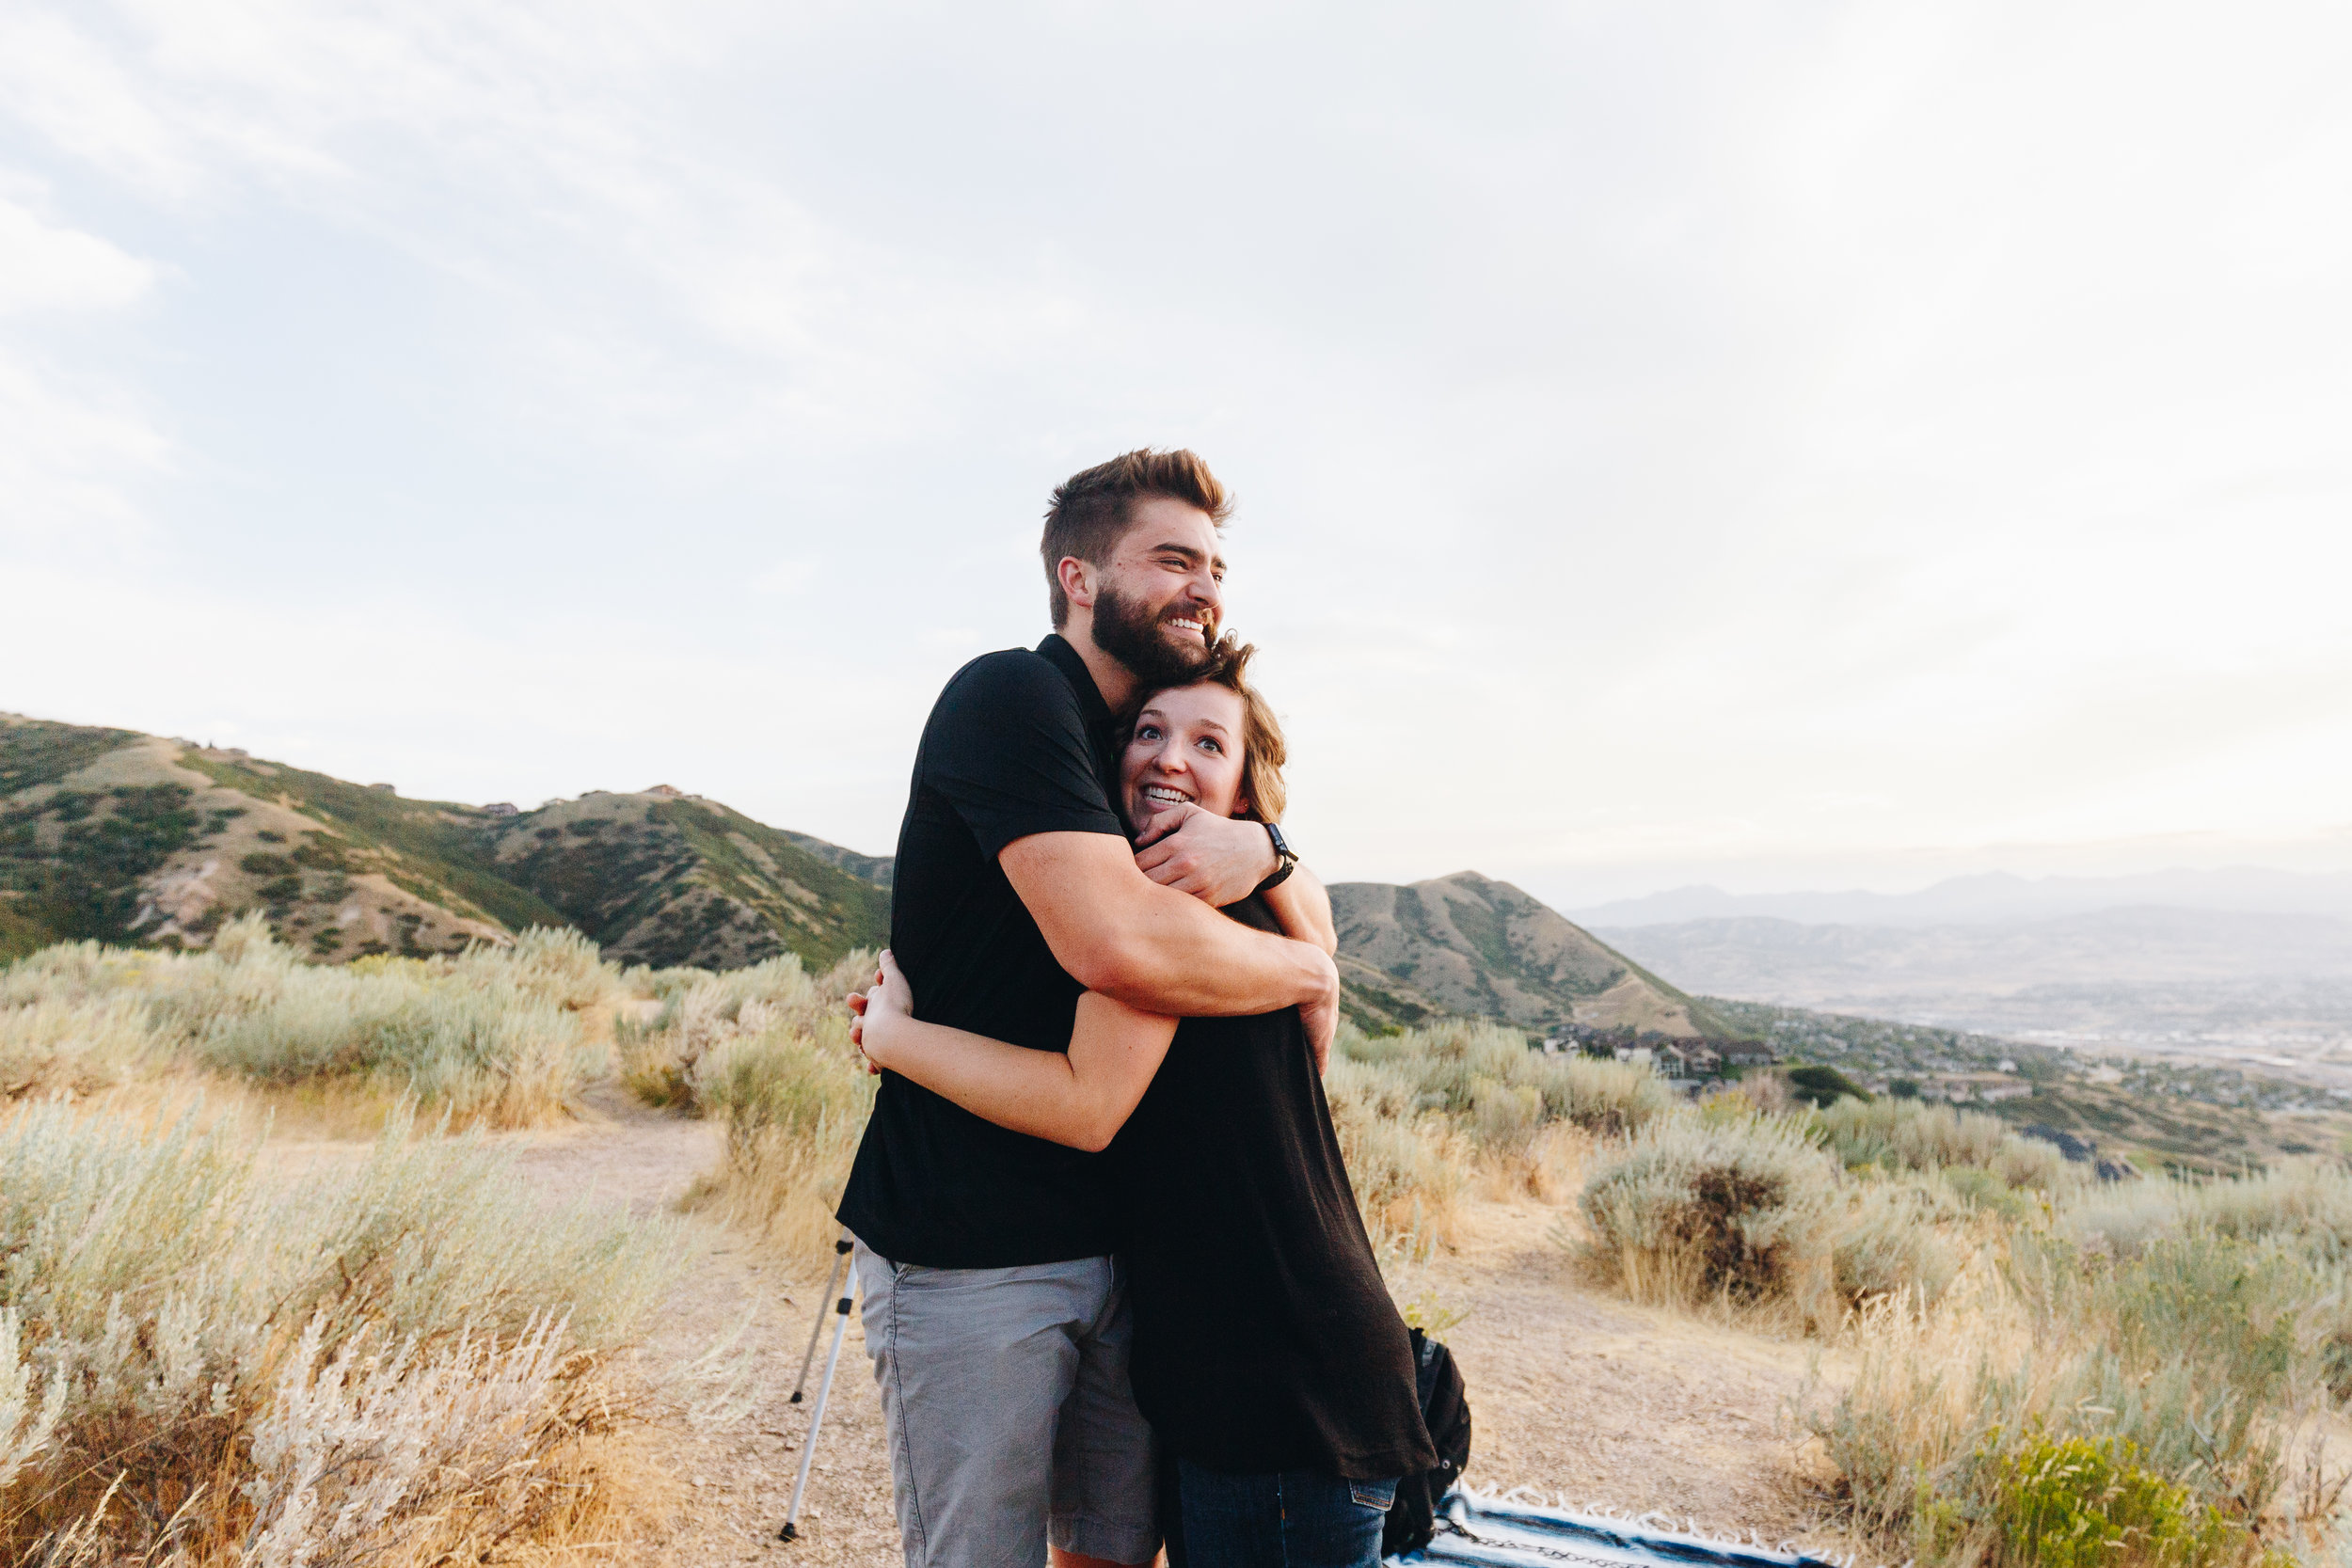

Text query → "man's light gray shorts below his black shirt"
[856,1242,1160,1568]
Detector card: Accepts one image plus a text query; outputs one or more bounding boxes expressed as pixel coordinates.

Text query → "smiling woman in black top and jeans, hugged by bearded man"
[851,641,1438,1568]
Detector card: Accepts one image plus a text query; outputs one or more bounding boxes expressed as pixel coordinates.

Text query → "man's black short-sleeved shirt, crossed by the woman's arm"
[840,637,1120,1270]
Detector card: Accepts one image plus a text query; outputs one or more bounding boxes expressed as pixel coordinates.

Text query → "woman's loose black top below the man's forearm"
[1110,898,1438,1481]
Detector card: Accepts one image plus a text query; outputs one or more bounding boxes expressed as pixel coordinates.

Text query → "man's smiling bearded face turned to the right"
[1094,496,1226,684]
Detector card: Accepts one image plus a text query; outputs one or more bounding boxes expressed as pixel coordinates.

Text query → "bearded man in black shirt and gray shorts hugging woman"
[840,451,1339,1568]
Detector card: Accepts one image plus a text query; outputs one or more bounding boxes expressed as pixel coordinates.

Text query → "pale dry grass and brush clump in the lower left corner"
[0,1105,675,1563]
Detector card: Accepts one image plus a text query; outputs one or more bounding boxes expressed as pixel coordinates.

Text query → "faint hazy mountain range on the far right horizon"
[1569,865,2352,928]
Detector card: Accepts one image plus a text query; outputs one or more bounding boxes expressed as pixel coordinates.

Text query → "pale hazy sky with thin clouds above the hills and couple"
[0,0,2352,905]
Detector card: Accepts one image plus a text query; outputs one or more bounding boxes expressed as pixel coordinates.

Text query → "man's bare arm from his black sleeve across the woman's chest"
[997,832,1339,1024]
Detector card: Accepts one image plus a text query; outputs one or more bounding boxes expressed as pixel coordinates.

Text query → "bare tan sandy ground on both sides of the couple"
[496,1091,1830,1568]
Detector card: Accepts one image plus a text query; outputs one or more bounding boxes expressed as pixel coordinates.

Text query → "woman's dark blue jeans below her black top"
[1162,1460,1397,1568]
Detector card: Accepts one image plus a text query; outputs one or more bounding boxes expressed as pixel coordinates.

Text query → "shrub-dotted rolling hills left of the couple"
[0,715,889,969]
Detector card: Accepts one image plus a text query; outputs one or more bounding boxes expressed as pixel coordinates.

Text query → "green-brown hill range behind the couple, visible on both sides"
[0,715,1729,1037]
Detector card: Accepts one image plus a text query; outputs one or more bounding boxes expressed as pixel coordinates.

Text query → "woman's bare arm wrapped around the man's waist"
[850,952,1176,1152]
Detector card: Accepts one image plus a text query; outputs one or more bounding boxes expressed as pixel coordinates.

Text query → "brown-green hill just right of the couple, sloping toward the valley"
[1331,872,1734,1039]
